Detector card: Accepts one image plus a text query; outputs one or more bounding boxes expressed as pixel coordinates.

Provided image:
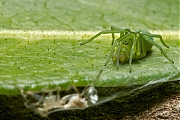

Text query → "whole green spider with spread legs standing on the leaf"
[80,26,174,73]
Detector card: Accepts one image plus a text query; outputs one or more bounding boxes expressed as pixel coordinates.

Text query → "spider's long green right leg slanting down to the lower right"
[142,36,174,63]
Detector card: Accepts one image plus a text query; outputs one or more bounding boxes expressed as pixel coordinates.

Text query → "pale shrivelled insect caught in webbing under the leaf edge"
[20,70,102,117]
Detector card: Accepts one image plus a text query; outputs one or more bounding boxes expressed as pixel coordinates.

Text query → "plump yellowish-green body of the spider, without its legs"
[112,30,154,64]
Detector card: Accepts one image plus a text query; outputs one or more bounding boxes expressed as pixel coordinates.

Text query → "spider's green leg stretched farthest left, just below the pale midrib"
[80,30,125,45]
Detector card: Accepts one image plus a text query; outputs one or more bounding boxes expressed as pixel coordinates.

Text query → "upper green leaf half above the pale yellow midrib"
[0,0,179,30]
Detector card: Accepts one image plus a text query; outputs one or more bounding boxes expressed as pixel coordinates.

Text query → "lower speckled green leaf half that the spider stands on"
[0,31,180,94]
